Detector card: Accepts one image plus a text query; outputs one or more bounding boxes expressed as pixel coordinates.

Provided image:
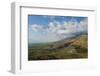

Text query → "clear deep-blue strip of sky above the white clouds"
[28,15,86,26]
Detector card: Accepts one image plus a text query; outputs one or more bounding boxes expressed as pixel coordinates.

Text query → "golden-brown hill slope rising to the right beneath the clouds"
[47,34,87,49]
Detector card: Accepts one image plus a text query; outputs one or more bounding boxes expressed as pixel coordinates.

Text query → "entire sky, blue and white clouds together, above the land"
[28,15,88,43]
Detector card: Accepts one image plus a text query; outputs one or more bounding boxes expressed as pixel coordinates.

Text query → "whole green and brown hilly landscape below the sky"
[28,35,88,60]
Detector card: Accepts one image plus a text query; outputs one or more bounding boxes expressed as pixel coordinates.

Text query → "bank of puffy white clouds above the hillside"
[31,19,88,41]
